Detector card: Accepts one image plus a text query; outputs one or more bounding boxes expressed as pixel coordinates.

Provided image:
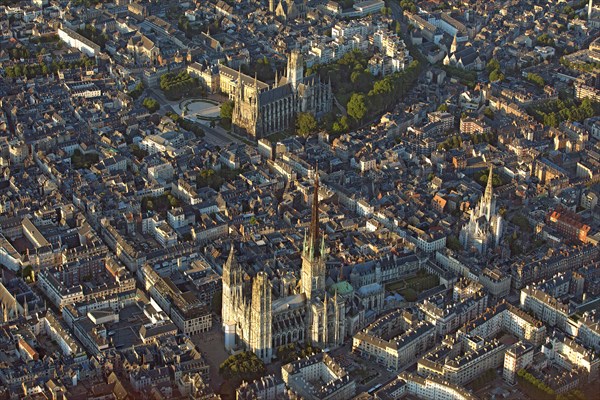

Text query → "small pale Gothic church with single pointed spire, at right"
[459,166,503,254]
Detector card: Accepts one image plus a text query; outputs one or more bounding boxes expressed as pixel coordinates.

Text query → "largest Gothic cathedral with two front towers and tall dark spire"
[222,177,347,363]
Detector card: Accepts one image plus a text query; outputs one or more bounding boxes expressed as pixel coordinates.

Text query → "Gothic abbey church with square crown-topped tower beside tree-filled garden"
[232,50,333,139]
